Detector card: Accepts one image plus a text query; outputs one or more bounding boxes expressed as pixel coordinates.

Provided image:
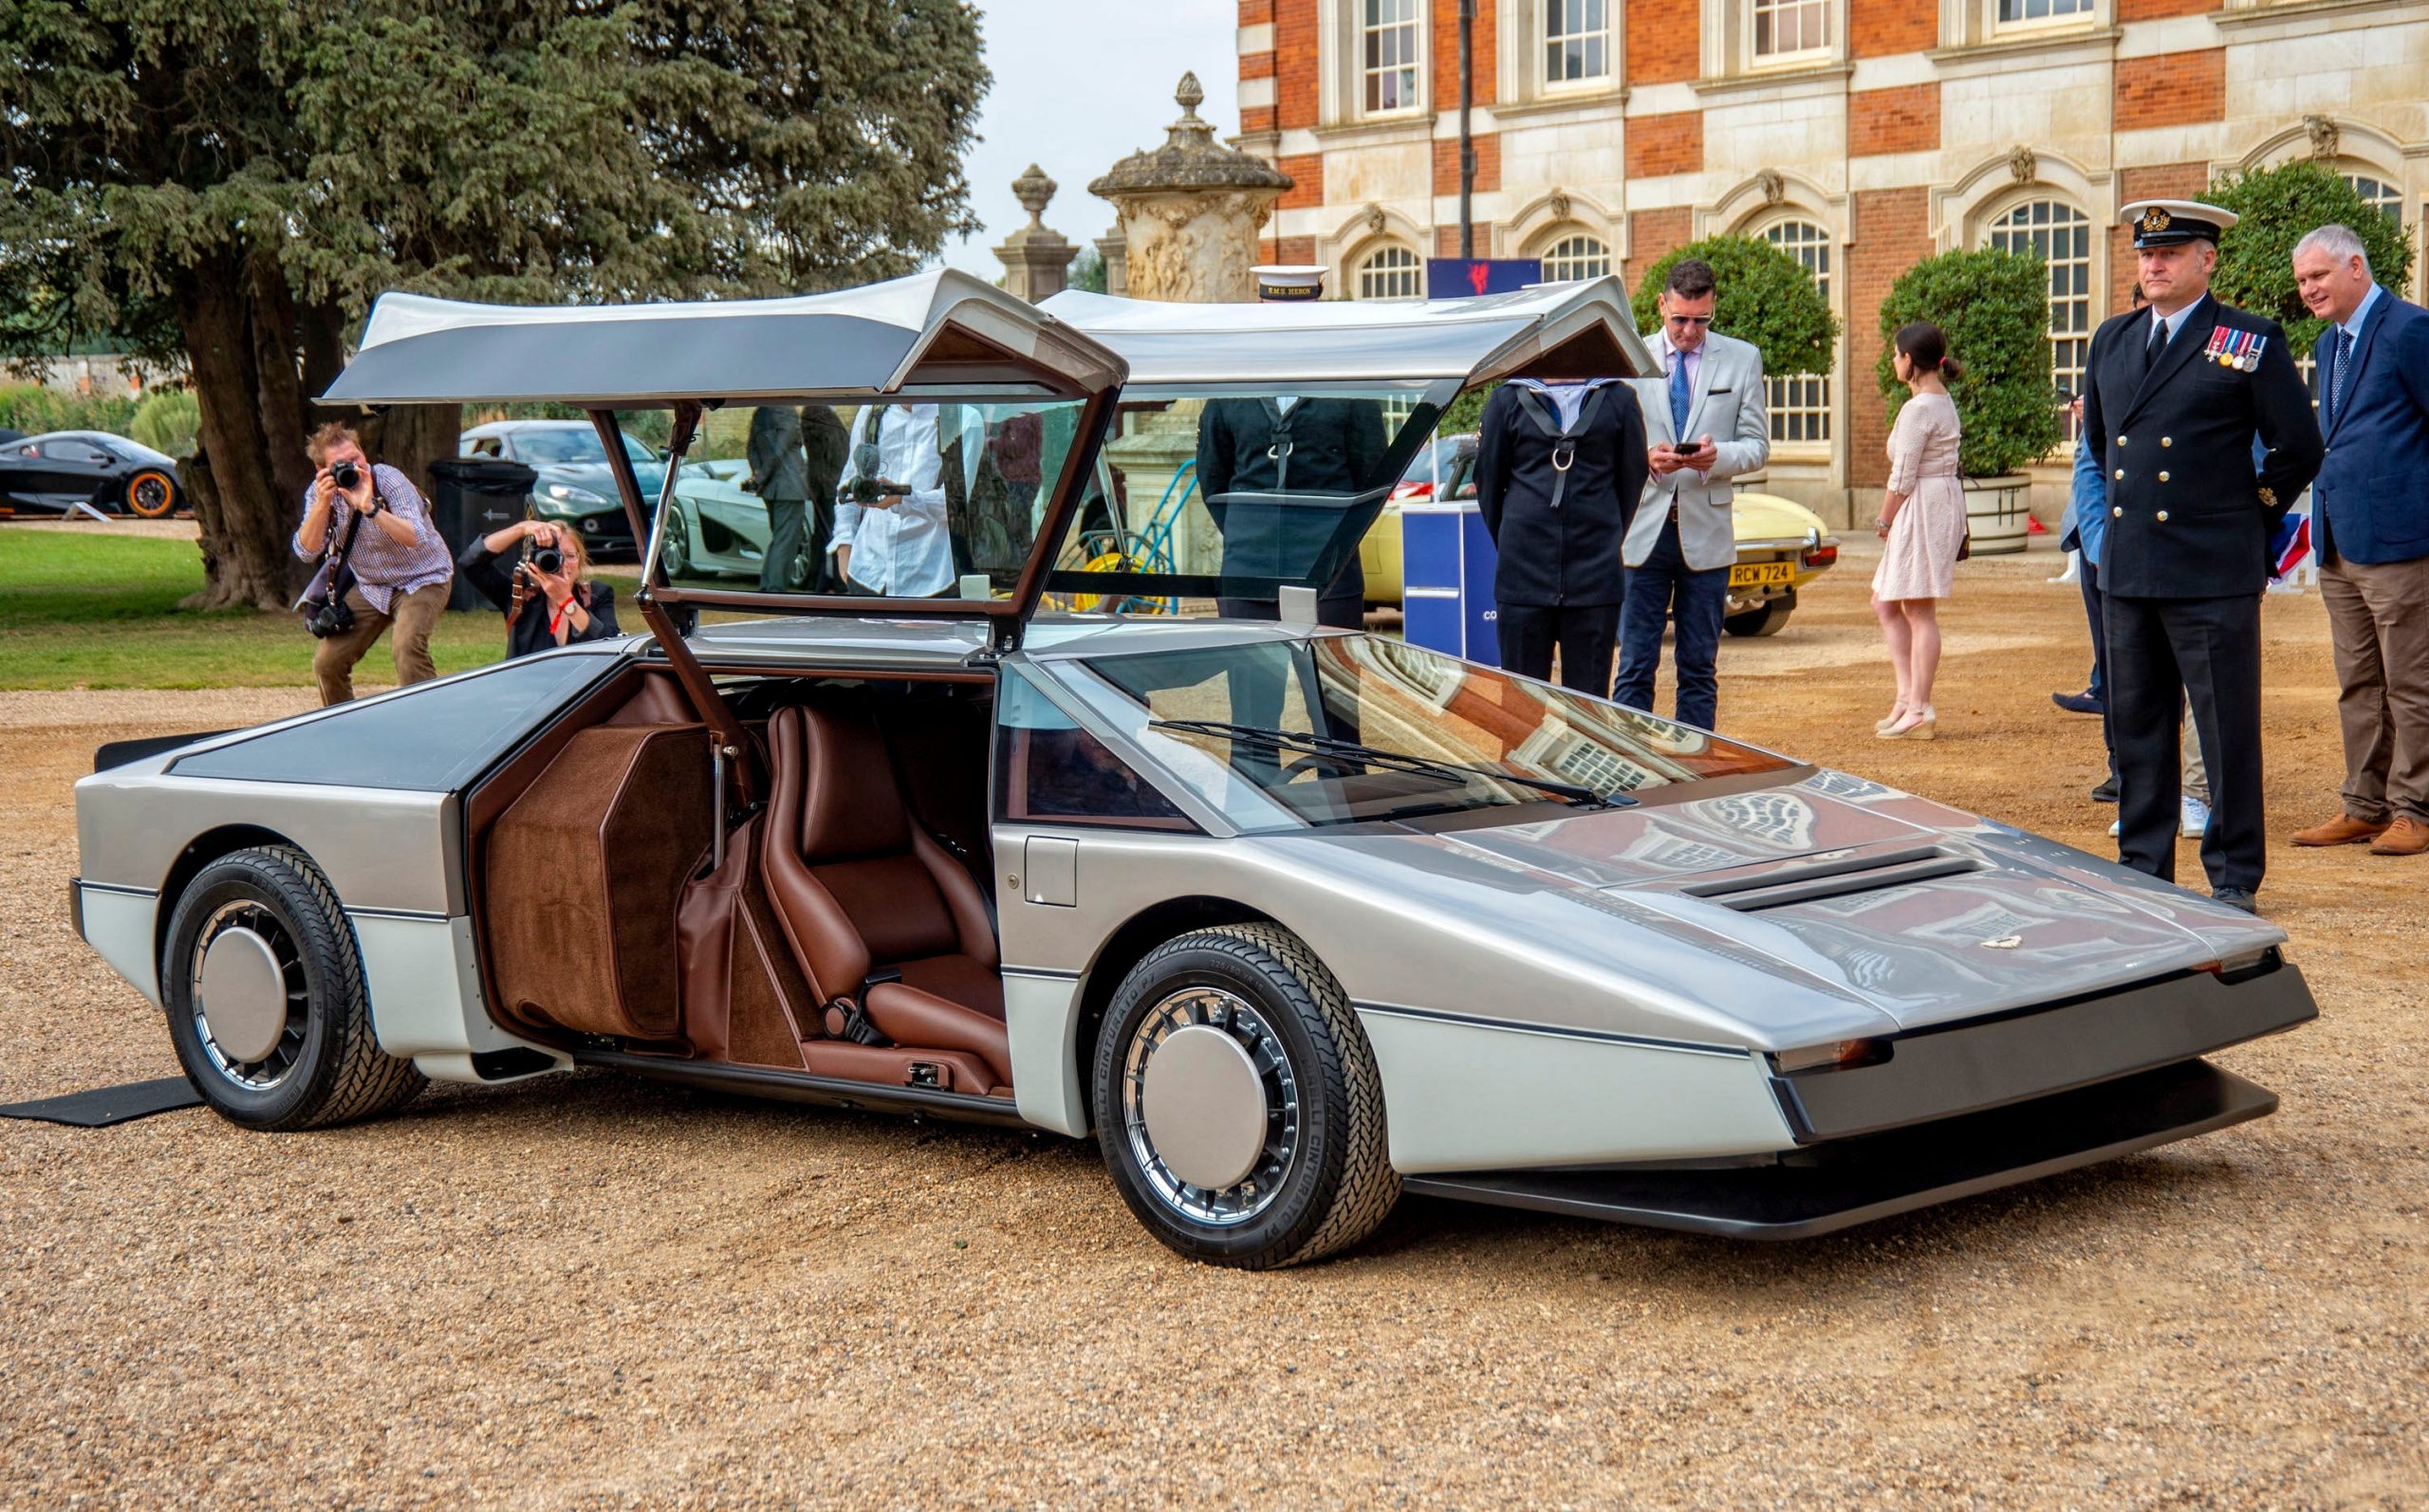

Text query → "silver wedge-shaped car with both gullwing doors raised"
[75,272,2315,1267]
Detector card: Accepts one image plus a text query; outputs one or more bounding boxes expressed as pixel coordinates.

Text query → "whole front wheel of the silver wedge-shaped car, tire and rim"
[1090,925,1400,1269]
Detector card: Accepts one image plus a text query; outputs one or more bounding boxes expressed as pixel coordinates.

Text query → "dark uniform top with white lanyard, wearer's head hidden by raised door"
[1476,383,1649,607]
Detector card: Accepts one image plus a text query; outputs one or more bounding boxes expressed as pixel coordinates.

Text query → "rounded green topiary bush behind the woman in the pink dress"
[1873,250,2060,478]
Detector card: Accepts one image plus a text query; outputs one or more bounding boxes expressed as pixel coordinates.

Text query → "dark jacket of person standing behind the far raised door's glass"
[1197,398,1384,597]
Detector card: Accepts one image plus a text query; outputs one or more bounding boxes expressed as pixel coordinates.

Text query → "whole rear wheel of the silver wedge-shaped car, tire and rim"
[160,844,425,1131]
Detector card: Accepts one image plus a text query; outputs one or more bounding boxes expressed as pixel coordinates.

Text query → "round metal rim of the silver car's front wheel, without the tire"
[1122,987,1300,1228]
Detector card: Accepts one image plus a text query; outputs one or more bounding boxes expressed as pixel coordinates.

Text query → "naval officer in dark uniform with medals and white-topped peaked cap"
[2084,199,2320,913]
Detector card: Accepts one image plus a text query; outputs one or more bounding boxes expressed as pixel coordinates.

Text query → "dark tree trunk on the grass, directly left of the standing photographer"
[175,252,301,609]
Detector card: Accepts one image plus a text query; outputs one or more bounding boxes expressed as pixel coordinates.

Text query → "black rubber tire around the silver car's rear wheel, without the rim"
[160,850,362,1129]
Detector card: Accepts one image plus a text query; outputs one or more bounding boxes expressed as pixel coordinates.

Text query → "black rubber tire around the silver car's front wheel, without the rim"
[1090,934,1348,1267]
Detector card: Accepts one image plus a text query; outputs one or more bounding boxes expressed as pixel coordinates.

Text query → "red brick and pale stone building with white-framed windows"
[1239,0,2429,520]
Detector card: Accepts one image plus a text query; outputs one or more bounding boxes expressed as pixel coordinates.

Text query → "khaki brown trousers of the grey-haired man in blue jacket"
[2320,556,2429,825]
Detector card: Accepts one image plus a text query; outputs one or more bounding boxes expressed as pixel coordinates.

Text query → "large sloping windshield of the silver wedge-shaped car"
[1079,636,1790,833]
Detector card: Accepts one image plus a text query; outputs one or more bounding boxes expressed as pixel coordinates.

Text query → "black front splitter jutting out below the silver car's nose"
[1401,1060,2278,1240]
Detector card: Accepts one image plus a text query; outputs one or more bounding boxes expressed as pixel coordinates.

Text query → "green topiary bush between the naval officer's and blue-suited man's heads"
[2208,157,2412,357]
